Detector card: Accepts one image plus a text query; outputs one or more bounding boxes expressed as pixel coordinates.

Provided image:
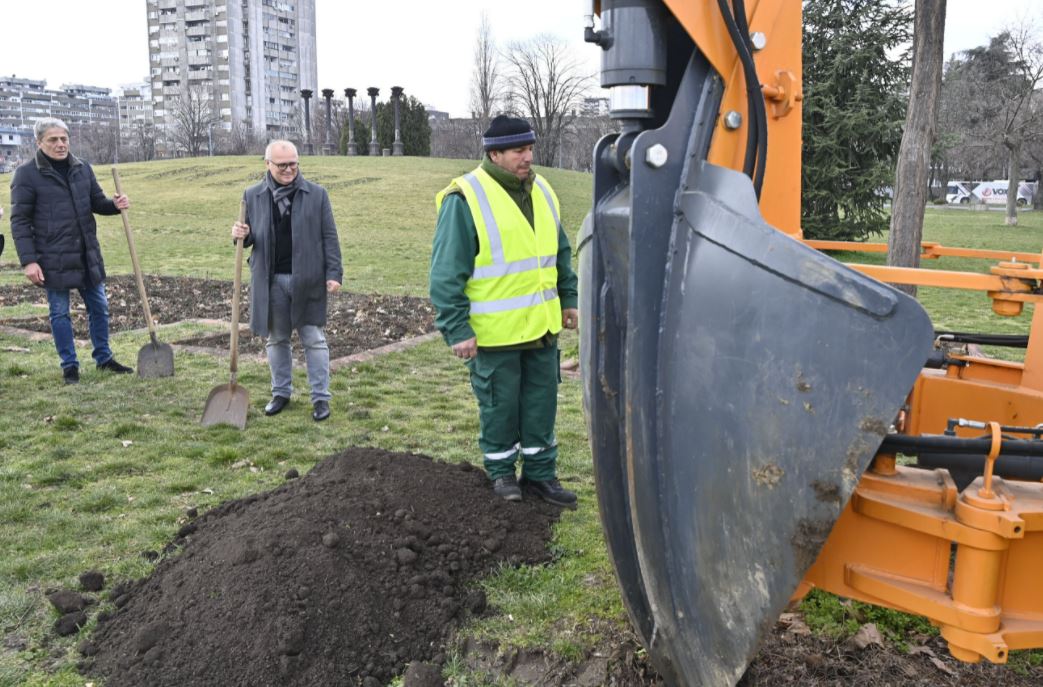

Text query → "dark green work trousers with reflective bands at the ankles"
[467,341,560,481]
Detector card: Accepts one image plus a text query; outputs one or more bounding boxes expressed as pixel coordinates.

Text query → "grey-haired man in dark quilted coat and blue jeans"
[10,118,134,384]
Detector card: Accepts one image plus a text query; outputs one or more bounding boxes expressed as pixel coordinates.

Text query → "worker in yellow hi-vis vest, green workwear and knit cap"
[431,115,579,508]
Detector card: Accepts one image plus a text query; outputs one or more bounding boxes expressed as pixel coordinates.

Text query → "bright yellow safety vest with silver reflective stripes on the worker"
[435,167,561,346]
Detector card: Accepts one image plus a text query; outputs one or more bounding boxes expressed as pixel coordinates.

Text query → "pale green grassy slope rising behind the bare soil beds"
[0,157,590,295]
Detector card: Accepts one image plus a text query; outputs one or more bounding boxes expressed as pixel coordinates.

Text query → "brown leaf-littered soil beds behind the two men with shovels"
[0,275,434,358]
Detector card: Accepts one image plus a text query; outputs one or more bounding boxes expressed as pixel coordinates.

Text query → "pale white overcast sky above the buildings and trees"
[0,0,1043,116]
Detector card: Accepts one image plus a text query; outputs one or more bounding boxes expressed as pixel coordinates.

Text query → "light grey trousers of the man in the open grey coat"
[267,274,331,403]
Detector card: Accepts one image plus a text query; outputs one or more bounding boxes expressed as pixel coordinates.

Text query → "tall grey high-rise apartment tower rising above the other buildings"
[146,0,318,136]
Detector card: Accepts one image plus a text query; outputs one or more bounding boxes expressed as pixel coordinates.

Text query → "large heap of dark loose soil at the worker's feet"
[81,448,558,687]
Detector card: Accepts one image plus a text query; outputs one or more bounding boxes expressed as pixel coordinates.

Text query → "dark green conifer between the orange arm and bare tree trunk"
[801,0,913,240]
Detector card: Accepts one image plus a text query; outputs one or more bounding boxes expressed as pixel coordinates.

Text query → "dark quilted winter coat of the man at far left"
[10,150,120,289]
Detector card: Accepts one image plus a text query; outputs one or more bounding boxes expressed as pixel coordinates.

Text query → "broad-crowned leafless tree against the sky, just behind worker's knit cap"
[504,33,590,166]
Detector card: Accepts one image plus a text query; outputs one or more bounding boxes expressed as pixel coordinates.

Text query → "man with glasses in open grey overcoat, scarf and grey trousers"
[232,141,343,422]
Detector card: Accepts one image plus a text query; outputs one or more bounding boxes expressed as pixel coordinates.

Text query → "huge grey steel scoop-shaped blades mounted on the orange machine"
[578,16,932,686]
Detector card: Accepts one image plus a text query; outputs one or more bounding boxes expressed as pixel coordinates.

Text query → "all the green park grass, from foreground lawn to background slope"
[0,157,1043,687]
